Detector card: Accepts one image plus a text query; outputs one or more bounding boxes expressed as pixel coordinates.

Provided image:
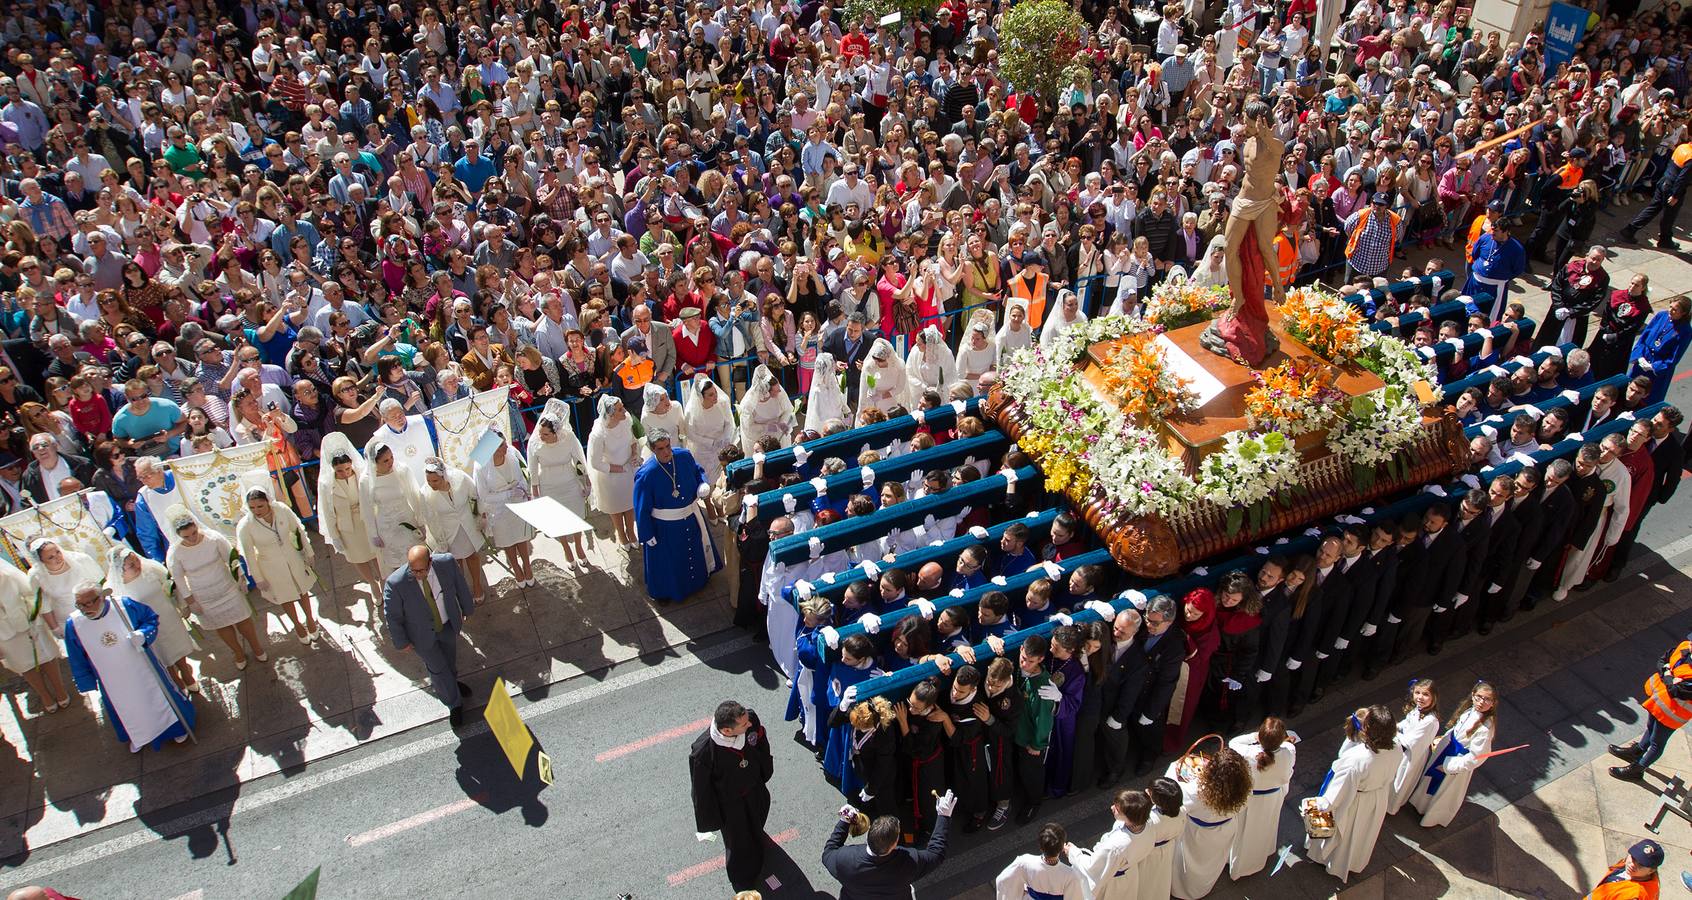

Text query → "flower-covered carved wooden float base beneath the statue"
[985,275,1467,577]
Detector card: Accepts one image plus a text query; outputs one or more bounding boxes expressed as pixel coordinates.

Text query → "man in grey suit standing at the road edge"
[382,545,475,729]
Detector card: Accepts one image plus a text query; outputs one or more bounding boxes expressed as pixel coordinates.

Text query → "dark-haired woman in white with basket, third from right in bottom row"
[1305,704,1404,883]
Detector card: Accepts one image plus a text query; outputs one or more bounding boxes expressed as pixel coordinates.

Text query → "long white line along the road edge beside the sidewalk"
[5,636,753,885]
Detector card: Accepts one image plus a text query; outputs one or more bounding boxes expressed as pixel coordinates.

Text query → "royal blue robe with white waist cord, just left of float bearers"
[635,448,722,602]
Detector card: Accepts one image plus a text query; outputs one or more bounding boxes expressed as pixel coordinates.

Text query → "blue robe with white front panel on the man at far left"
[64,597,195,749]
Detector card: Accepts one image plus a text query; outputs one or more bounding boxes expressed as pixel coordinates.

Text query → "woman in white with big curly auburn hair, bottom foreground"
[1167,748,1252,900]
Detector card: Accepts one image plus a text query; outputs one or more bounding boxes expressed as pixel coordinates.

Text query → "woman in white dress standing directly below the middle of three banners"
[164,508,271,668]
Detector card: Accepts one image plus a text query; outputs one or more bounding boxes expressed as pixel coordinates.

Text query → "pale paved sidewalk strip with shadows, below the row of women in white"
[0,519,731,859]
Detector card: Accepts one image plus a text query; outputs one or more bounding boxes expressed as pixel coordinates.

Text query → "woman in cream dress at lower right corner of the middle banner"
[235,487,321,643]
